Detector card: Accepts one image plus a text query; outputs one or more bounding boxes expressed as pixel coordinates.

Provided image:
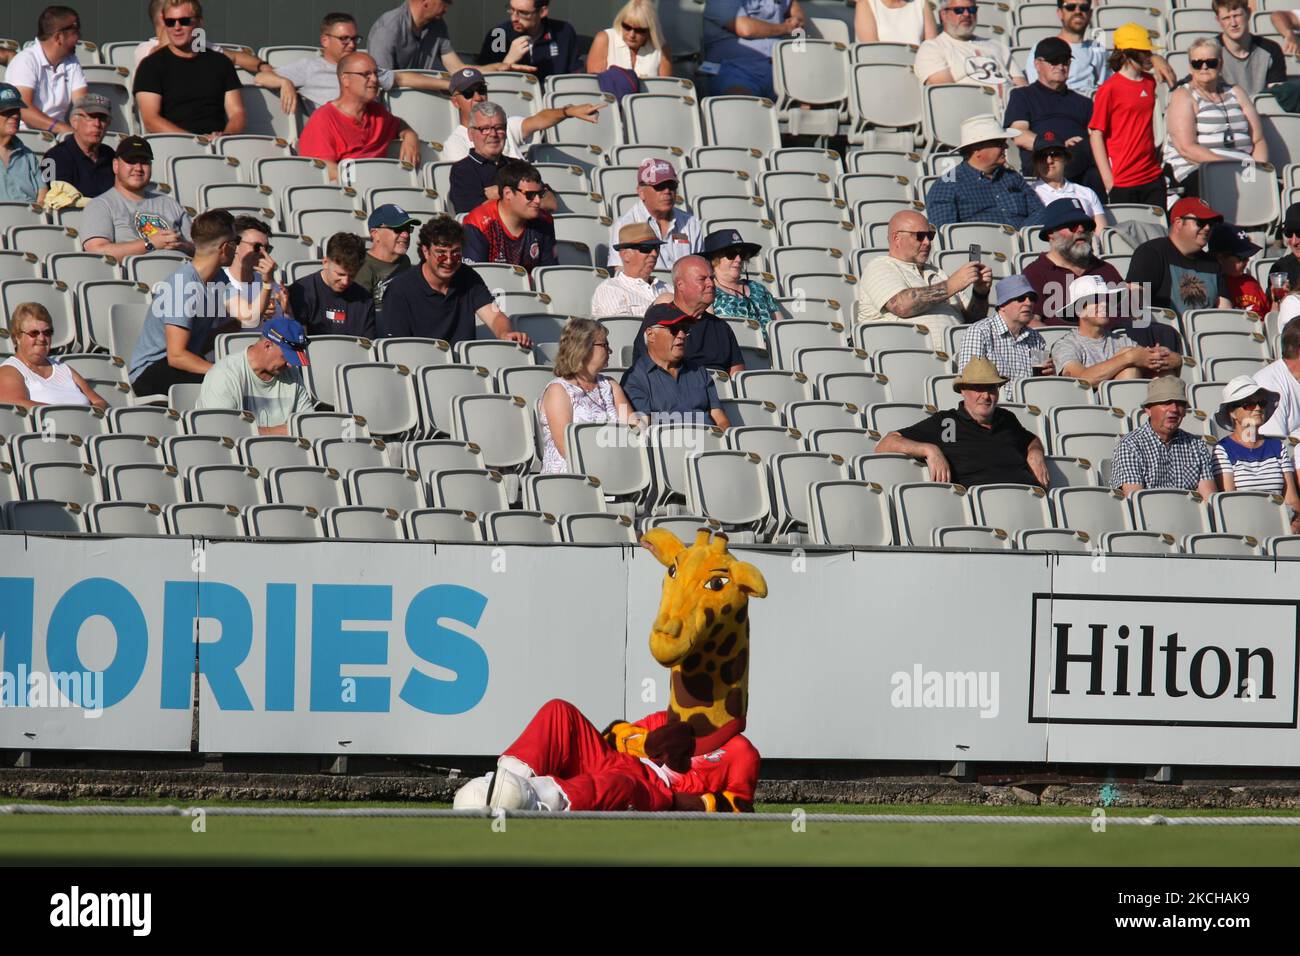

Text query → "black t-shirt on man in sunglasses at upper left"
[135,47,239,135]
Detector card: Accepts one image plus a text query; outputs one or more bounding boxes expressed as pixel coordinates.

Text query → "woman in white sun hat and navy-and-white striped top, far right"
[1214,375,1300,533]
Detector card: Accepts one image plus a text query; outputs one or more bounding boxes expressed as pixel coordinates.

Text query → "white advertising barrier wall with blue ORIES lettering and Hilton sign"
[0,535,1300,766]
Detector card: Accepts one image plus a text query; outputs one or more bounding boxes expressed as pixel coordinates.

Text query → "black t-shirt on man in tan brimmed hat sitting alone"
[898,405,1039,486]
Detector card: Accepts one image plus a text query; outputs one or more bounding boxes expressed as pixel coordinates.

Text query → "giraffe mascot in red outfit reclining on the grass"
[455,528,767,813]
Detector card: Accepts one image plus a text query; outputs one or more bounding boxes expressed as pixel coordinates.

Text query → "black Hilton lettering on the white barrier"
[1052,623,1277,700]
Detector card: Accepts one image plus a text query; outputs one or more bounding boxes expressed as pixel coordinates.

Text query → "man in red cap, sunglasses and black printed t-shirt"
[1128,195,1232,316]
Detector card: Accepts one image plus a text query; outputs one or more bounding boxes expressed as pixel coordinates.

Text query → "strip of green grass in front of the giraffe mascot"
[0,797,1300,866]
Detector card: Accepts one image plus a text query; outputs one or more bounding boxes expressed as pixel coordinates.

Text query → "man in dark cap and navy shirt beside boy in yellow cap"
[1005,36,1101,203]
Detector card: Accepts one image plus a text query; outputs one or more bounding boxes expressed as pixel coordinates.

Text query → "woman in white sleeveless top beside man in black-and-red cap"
[538,319,634,475]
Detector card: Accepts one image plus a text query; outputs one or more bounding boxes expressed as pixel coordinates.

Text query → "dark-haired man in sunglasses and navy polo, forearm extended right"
[380,216,533,349]
